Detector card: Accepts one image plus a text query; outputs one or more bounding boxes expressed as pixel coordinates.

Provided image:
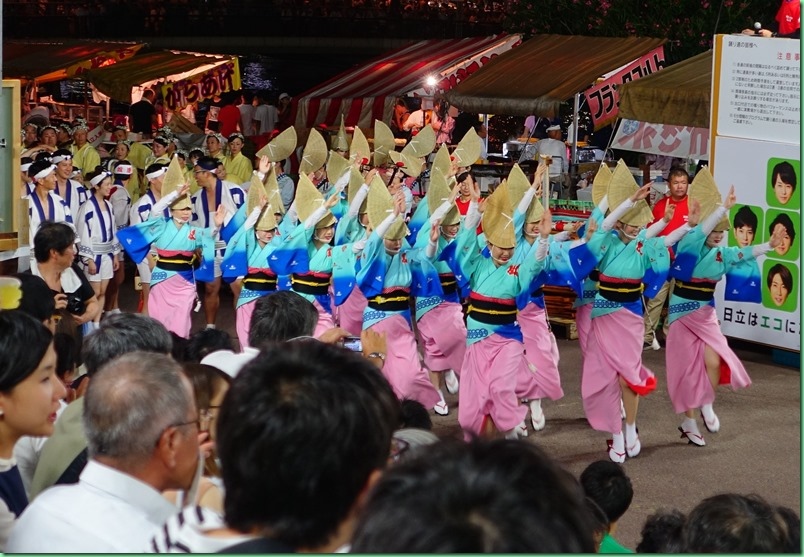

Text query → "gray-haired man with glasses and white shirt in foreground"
[6,352,200,553]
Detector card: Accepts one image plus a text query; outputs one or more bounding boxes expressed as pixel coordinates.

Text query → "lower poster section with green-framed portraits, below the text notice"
[714,137,801,350]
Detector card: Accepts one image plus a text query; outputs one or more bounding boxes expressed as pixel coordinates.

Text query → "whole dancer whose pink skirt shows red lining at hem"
[581,161,695,462]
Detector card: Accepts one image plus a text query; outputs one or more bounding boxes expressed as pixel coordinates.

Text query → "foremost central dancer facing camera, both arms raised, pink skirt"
[455,183,551,438]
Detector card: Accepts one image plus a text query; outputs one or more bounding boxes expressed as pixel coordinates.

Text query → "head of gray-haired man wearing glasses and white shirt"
[84,352,199,491]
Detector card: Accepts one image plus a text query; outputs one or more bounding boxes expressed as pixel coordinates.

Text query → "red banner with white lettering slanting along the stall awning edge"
[584,46,665,129]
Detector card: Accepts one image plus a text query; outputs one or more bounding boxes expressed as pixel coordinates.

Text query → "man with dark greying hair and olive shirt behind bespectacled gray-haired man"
[30,313,173,499]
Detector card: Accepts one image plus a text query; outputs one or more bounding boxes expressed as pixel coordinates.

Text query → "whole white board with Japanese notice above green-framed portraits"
[710,35,802,351]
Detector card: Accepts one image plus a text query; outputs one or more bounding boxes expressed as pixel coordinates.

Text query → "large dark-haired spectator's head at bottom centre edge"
[352,440,595,553]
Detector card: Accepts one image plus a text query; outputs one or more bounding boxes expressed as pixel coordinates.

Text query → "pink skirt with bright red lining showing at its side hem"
[581,309,656,433]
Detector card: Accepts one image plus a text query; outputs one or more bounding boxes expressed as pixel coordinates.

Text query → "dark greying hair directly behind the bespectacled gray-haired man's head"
[82,313,172,377]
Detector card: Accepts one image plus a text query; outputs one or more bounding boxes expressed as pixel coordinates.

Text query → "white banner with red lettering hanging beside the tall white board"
[611,118,709,160]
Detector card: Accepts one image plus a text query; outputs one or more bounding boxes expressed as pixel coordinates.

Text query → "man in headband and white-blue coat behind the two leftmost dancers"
[192,157,246,329]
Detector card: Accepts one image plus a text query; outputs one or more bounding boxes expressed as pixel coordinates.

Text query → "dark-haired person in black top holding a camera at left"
[34,221,100,326]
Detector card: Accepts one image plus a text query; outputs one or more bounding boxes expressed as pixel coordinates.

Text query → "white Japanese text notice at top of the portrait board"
[713,35,801,144]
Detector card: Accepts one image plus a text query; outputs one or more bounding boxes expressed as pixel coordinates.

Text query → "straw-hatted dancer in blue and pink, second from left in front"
[222,175,282,348]
